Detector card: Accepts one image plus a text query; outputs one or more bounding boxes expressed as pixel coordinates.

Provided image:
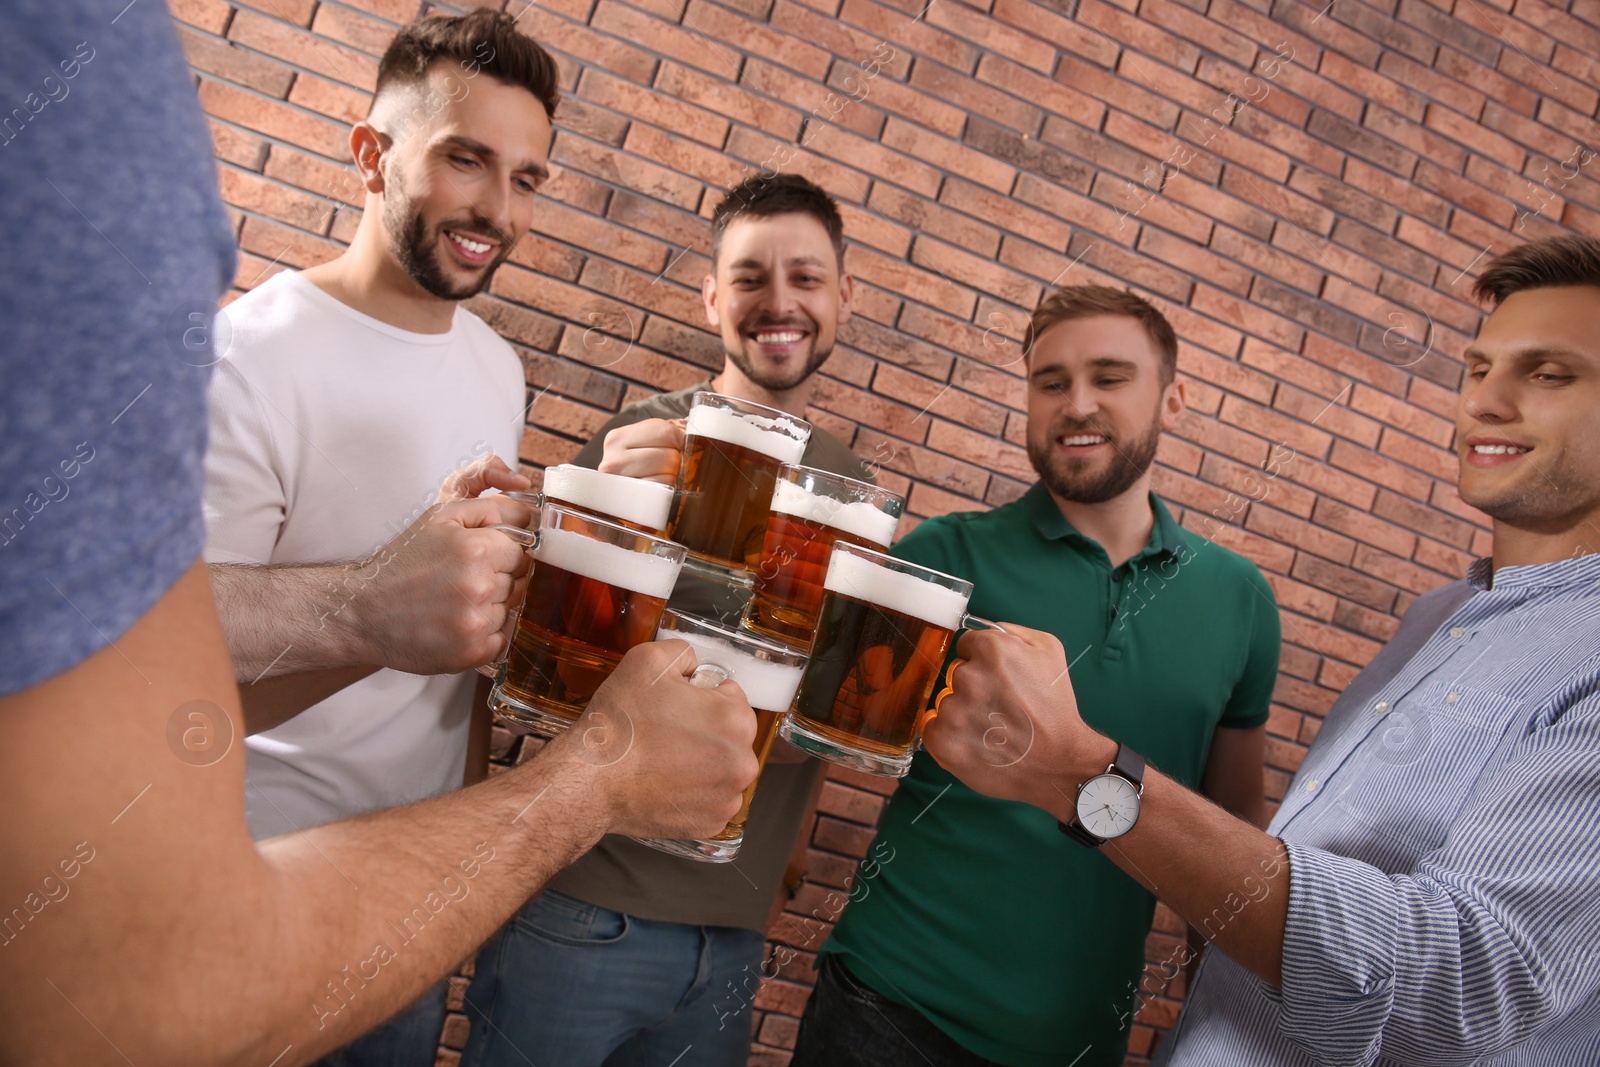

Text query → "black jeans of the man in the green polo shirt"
[789,955,998,1067]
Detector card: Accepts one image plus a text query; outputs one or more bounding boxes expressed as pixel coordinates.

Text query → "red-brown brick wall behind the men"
[181,0,1600,1064]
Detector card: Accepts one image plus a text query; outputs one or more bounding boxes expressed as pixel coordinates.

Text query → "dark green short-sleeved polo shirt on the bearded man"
[822,485,1280,1067]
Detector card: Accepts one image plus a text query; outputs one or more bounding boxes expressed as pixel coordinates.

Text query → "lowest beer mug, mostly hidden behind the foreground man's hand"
[635,611,805,864]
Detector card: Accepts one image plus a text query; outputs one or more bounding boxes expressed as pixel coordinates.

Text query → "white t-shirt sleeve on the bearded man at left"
[205,360,288,563]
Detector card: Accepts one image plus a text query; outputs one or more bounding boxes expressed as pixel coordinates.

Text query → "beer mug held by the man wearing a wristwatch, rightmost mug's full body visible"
[779,541,1000,777]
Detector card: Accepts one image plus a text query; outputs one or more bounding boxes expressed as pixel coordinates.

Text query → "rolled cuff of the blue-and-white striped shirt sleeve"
[1270,845,1400,1064]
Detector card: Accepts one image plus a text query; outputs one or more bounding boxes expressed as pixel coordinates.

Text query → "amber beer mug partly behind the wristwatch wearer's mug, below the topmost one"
[744,464,906,648]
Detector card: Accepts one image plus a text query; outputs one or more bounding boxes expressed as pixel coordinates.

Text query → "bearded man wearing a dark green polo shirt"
[792,286,1280,1067]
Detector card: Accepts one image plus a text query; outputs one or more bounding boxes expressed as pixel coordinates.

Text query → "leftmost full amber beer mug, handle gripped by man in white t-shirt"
[490,502,683,737]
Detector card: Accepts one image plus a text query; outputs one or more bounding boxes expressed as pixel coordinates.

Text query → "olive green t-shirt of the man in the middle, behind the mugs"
[550,382,872,929]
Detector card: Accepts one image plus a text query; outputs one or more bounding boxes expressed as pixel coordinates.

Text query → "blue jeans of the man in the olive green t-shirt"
[461,893,765,1067]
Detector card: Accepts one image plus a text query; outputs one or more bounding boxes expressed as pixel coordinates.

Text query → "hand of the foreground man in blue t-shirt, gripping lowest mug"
[539,641,758,838]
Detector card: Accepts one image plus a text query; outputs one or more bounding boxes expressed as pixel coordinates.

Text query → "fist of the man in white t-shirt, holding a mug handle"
[339,496,533,673]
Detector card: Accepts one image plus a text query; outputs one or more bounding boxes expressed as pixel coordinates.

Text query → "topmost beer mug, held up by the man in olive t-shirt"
[667,392,811,571]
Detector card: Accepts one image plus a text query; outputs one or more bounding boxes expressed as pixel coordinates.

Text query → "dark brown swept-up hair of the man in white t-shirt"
[373,8,562,118]
